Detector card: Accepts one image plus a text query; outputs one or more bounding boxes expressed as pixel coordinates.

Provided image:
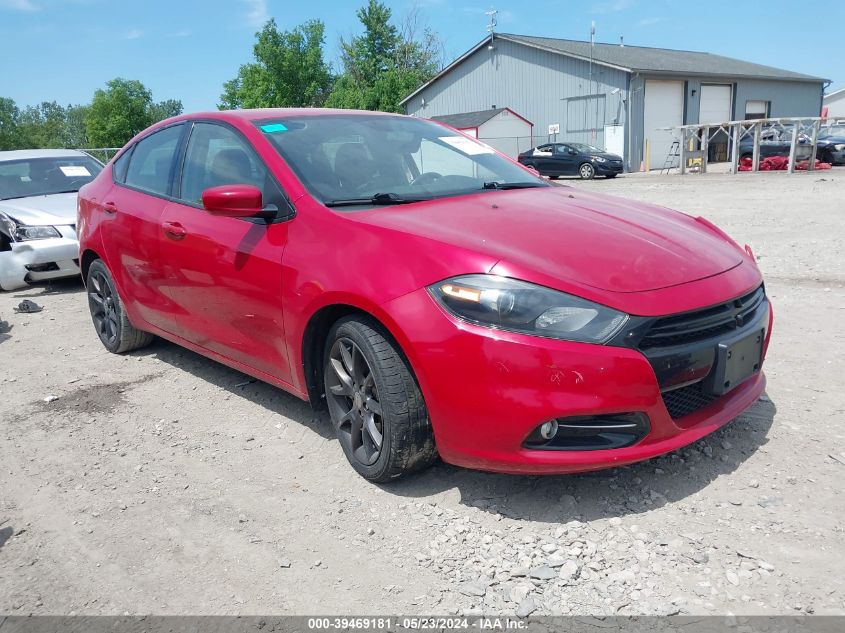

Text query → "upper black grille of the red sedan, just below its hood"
[639,286,766,349]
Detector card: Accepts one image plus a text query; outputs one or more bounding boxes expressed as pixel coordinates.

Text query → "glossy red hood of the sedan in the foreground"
[347,186,743,292]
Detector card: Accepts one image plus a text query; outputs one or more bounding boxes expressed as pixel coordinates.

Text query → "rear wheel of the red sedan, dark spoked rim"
[85,259,155,354]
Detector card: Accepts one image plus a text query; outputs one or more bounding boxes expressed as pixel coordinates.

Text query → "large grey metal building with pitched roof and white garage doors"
[402,33,829,171]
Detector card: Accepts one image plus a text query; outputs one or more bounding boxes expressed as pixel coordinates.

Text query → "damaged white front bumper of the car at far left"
[0,227,80,290]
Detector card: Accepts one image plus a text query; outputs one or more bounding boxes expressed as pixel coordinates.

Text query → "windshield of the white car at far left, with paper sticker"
[0,154,103,200]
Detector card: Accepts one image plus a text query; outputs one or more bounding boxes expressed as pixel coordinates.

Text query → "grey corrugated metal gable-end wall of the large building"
[406,40,628,152]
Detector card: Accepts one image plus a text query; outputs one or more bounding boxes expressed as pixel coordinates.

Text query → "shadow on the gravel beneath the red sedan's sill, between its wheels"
[128,338,332,440]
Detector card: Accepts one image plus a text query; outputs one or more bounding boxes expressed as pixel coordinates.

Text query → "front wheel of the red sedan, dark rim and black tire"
[323,316,437,483]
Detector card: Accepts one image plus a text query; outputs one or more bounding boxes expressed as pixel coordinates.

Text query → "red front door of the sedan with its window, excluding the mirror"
[161,122,292,382]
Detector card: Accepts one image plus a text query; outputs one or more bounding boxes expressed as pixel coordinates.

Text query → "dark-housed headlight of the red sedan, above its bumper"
[428,275,628,343]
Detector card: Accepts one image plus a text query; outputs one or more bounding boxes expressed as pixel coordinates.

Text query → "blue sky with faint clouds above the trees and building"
[0,0,845,112]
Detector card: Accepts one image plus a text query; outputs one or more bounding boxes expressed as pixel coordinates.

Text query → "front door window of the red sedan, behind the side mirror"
[179,123,283,208]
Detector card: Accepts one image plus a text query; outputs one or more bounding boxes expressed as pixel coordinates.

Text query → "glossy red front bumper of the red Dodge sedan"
[388,278,771,474]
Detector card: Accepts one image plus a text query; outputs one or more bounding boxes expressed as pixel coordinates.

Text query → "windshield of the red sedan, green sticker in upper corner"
[256,114,547,206]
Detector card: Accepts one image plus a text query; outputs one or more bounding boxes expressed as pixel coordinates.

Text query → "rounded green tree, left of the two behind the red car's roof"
[218,19,332,110]
